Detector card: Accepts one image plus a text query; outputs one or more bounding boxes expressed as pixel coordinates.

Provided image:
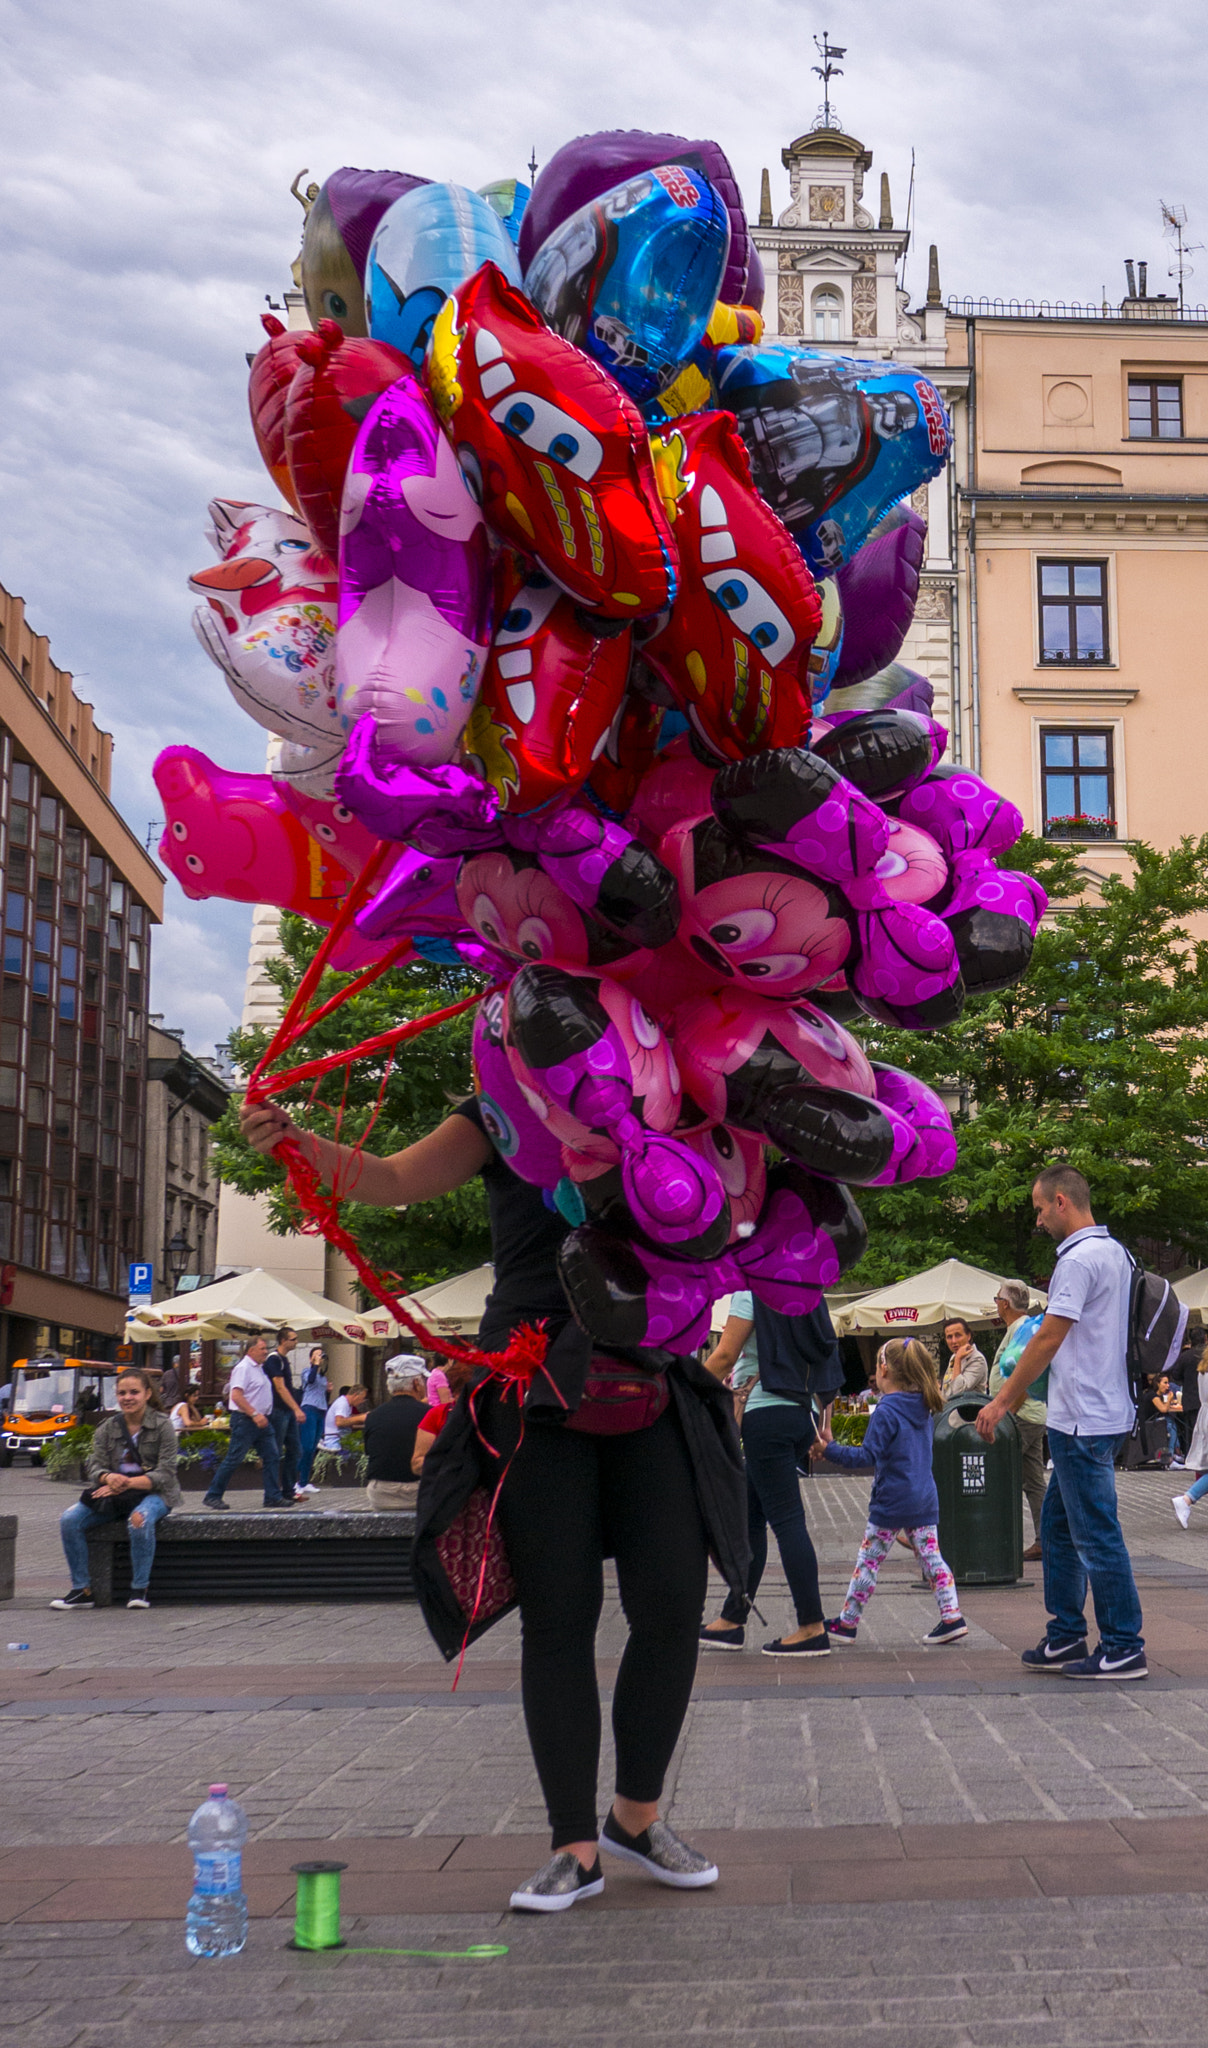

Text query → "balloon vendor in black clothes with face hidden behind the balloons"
[242,1098,747,1913]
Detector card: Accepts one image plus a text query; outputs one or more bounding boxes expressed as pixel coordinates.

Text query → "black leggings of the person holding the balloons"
[500,1409,708,1849]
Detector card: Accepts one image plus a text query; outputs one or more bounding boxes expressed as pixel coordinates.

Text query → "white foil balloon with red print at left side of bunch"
[188,498,346,786]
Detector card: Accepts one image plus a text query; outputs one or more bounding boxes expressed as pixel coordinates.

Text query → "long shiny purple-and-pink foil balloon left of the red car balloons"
[336,375,491,768]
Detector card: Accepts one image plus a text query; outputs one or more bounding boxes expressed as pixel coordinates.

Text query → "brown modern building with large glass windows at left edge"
[0,590,164,1364]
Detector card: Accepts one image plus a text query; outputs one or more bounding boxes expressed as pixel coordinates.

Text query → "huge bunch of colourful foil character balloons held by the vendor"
[156,131,1044,1350]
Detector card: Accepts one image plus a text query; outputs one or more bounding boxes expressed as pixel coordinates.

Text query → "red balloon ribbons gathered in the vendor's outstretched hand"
[244,840,547,1384]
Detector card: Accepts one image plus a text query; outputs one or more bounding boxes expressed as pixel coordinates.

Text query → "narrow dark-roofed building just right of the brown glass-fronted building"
[143,1016,231,1300]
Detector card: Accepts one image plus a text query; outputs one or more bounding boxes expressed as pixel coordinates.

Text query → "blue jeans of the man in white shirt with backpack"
[1040,1425,1145,1657]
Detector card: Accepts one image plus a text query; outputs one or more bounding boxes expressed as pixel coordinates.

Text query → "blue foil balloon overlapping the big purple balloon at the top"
[524,164,729,406]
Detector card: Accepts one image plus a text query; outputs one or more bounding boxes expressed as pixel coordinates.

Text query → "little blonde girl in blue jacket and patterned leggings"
[809,1337,968,1642]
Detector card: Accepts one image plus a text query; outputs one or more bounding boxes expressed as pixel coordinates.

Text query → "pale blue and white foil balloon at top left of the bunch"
[364,184,520,369]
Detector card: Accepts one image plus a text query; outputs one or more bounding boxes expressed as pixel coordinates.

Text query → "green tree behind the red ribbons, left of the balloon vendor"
[213,913,491,1288]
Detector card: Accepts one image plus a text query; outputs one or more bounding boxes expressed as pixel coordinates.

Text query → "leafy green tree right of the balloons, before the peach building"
[846,836,1208,1286]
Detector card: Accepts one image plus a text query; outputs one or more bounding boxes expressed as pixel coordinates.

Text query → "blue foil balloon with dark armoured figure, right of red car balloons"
[713,344,952,575]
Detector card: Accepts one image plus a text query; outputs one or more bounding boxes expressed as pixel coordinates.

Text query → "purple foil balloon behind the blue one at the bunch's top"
[520,129,751,305]
